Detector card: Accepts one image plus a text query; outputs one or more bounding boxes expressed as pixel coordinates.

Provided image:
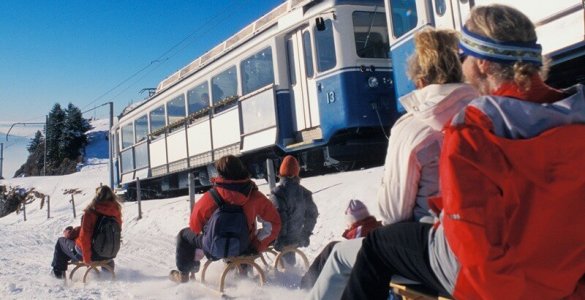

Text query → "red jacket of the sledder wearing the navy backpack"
[189,178,281,252]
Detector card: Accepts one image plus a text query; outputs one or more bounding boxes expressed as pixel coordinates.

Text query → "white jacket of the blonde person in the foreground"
[378,83,478,224]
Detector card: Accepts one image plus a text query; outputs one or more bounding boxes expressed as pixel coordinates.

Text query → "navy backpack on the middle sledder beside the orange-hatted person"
[203,189,250,260]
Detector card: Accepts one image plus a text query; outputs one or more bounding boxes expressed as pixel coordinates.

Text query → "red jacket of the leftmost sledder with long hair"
[75,202,122,264]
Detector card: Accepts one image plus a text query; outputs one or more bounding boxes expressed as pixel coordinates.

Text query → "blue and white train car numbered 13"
[112,0,399,197]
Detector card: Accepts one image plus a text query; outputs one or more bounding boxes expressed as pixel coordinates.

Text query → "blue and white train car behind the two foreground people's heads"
[384,0,585,102]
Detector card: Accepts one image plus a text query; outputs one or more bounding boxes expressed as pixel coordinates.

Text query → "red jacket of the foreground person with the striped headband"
[436,88,585,299]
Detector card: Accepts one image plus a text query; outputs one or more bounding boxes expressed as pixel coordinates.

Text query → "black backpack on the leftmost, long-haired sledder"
[91,215,122,259]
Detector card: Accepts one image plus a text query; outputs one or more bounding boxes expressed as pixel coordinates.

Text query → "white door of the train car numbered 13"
[286,27,320,132]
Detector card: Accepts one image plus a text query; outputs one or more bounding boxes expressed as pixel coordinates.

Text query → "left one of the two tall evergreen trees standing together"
[46,103,65,169]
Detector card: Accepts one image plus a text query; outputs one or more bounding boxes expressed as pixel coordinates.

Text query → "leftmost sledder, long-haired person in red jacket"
[51,185,122,278]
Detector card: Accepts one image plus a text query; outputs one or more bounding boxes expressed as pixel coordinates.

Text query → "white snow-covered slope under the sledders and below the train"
[0,123,382,299]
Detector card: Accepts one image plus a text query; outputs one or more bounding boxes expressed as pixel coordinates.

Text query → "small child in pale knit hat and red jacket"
[300,199,382,289]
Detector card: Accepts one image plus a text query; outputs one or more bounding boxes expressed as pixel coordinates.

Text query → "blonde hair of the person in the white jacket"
[408,29,463,85]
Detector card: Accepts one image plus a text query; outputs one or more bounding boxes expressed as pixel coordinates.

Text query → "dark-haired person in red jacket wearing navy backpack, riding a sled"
[169,155,281,282]
